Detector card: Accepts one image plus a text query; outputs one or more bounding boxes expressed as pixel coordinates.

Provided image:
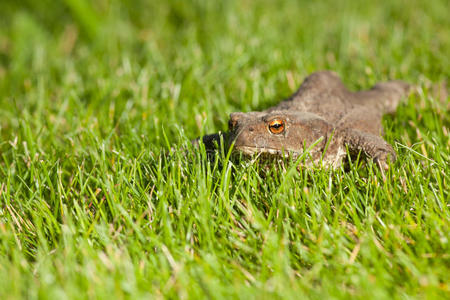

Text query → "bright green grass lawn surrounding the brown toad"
[0,0,450,299]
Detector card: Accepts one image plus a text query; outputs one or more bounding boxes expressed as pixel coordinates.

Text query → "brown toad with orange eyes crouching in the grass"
[194,71,409,168]
